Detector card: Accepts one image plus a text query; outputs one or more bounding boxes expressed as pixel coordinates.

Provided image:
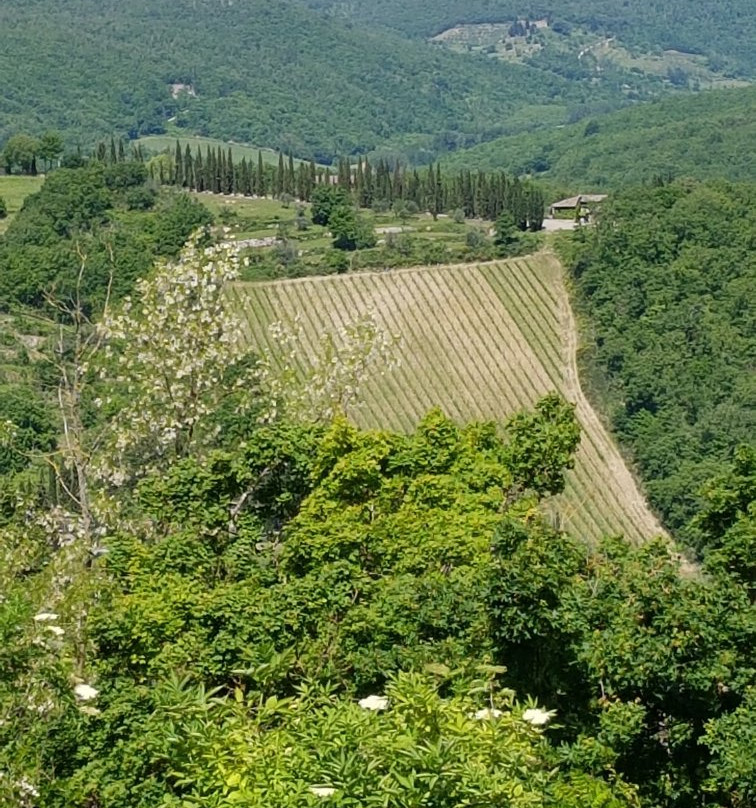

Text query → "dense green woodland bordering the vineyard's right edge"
[570,181,756,552]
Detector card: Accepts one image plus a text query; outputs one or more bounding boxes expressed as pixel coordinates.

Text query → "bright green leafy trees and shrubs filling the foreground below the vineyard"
[0,399,756,808]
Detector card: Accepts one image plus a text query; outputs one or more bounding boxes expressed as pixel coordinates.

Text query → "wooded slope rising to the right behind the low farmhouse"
[447,87,756,191]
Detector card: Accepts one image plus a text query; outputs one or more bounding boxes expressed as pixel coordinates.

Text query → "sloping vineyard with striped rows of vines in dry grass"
[233,253,662,542]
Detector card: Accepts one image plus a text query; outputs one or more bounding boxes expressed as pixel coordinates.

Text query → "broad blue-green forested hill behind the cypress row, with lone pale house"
[0,0,604,161]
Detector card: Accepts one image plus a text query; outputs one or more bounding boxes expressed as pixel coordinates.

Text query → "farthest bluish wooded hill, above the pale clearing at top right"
[309,0,756,75]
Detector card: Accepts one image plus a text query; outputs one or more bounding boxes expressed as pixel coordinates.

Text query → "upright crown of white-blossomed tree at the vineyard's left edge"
[98,237,251,485]
